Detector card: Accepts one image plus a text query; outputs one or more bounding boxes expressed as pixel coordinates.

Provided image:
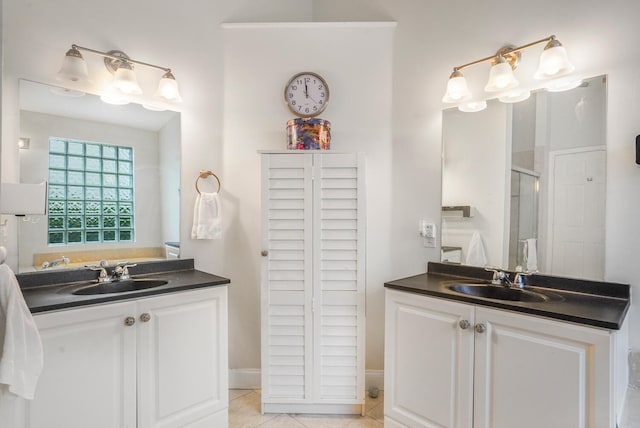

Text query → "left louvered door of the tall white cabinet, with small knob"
[262,154,313,404]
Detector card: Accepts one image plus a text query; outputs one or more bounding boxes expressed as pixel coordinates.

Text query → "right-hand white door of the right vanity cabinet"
[474,307,615,428]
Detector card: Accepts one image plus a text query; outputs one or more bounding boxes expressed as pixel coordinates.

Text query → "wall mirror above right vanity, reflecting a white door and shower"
[441,76,606,280]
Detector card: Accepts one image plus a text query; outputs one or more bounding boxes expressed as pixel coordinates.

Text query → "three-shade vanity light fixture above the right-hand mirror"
[442,36,580,103]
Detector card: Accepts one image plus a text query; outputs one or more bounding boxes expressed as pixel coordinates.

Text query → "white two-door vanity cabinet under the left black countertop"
[0,286,228,428]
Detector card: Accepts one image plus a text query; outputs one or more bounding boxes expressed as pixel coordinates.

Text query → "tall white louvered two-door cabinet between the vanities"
[261,152,365,414]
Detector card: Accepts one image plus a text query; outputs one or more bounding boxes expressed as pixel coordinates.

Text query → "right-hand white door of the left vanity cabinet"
[137,287,228,428]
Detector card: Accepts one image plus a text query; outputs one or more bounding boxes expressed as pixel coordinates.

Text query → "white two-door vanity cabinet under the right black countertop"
[385,289,616,428]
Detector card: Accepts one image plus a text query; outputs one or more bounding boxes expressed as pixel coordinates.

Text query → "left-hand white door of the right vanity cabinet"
[384,289,472,428]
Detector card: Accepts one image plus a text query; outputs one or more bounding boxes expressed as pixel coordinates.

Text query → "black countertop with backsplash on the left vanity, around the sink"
[16,259,231,313]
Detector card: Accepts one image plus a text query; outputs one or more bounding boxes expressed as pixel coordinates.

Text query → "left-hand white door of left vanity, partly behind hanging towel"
[24,303,136,428]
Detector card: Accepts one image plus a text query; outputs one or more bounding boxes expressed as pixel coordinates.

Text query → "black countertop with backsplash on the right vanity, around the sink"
[384,263,630,330]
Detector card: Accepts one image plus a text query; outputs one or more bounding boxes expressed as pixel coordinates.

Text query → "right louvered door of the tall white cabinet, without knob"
[313,154,365,403]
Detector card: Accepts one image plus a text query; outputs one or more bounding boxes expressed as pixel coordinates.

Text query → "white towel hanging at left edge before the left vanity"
[0,247,43,400]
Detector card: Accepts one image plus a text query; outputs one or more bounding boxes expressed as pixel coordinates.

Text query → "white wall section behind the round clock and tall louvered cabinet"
[222,23,396,368]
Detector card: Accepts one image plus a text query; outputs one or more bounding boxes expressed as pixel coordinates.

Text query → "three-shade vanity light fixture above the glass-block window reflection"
[56,44,182,104]
